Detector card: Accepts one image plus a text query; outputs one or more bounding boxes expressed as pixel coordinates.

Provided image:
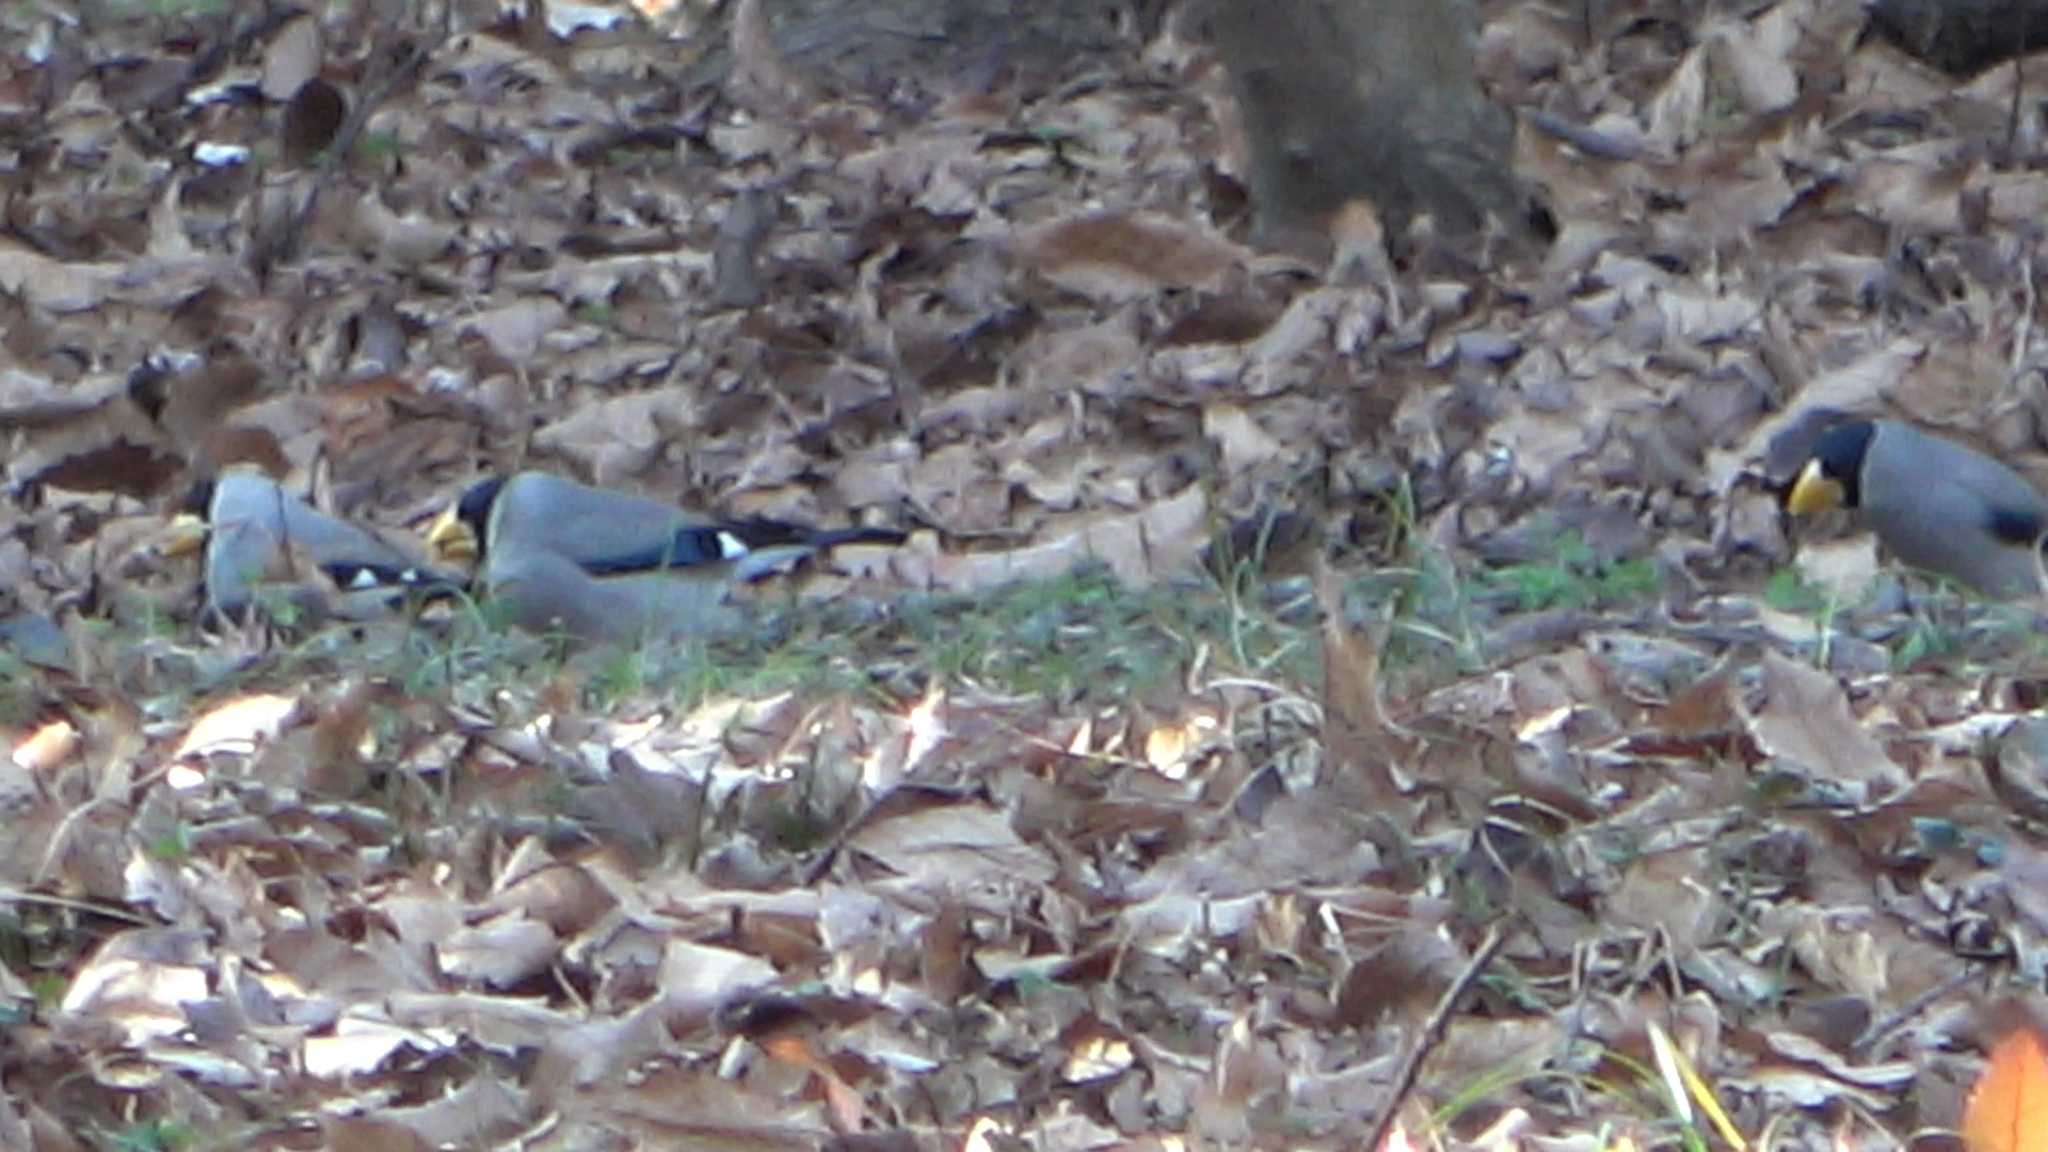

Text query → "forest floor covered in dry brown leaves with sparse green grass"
[0,0,2048,1152]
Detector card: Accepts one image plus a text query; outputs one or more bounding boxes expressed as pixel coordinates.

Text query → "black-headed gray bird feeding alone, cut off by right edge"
[1786,420,2048,599]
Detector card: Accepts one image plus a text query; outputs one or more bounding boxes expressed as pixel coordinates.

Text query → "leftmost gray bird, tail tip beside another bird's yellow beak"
[160,467,461,619]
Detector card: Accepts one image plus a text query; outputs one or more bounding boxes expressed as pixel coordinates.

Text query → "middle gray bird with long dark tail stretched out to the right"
[426,471,903,642]
